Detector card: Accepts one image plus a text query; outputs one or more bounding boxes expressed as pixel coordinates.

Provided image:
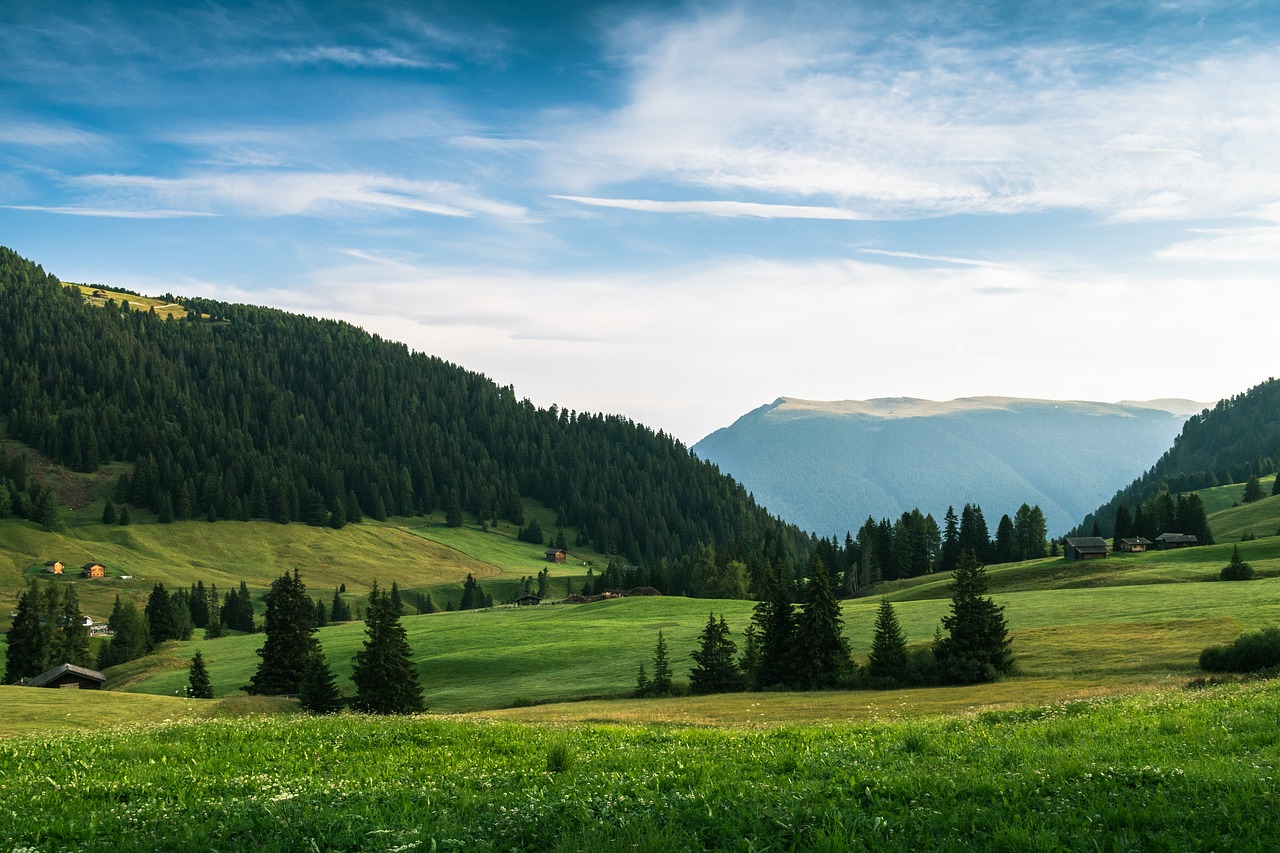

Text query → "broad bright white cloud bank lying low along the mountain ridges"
[225,252,1280,443]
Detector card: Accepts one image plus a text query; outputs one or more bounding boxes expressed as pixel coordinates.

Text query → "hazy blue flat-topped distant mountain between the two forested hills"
[692,397,1206,537]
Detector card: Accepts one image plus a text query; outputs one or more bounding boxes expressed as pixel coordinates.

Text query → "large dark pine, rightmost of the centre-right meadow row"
[934,551,1012,683]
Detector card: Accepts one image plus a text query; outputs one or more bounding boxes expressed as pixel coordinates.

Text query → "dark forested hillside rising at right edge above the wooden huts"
[1074,379,1280,535]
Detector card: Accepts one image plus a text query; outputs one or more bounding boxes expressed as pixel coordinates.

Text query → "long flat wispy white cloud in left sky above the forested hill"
[67,170,525,219]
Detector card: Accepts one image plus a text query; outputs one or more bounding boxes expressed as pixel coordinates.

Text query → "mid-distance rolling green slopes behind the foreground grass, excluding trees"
[0,455,1280,720]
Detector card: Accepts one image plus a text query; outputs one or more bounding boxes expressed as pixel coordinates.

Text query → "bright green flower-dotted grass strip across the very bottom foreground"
[0,683,1280,850]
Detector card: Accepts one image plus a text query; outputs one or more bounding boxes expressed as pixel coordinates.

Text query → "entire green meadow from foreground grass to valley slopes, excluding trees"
[0,471,1280,852]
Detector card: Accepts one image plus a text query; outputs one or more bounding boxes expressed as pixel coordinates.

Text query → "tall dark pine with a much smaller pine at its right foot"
[243,569,317,695]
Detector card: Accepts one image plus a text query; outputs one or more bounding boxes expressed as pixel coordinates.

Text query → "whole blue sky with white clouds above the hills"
[0,0,1280,444]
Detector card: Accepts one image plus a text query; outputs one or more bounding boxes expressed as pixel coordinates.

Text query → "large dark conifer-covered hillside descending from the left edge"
[0,248,810,573]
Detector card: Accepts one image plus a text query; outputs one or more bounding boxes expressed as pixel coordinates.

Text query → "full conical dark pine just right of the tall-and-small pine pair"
[351,581,425,713]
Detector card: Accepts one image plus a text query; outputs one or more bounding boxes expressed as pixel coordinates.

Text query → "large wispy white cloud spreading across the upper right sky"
[552,9,1280,220]
